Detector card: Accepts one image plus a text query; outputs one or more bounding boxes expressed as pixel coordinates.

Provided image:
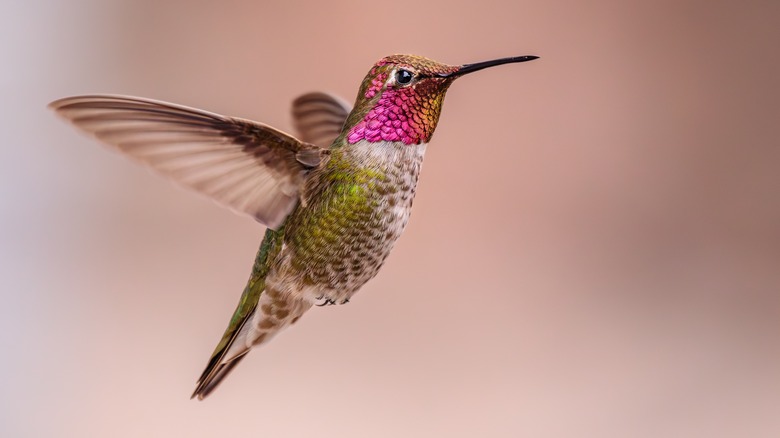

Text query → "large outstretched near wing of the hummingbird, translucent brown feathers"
[50,95,327,229]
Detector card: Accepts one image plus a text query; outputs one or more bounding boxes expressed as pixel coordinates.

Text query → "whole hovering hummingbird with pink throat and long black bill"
[50,55,538,400]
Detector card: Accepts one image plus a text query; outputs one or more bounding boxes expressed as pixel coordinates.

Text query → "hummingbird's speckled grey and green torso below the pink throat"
[266,143,425,305]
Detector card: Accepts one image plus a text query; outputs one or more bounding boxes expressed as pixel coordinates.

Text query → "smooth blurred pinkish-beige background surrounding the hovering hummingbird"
[0,0,780,437]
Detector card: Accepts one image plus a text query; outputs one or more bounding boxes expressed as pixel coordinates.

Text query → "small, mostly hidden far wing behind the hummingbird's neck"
[292,92,352,148]
